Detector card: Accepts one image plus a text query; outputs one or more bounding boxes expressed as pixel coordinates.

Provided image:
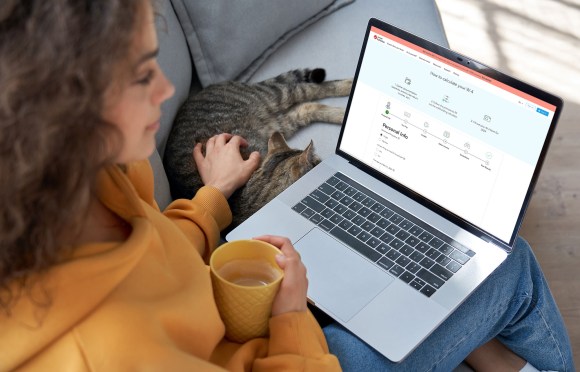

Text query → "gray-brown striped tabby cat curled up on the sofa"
[164,68,352,227]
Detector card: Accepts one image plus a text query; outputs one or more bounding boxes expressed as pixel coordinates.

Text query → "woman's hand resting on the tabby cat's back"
[193,133,260,198]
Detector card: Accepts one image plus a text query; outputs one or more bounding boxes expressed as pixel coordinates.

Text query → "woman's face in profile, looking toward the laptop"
[104,1,175,164]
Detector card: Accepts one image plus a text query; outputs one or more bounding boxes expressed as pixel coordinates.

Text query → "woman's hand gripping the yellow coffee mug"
[254,235,308,316]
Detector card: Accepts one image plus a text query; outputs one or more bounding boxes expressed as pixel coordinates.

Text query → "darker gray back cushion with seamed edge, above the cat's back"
[173,0,353,86]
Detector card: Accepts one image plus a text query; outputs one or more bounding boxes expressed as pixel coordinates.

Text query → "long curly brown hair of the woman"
[0,0,148,310]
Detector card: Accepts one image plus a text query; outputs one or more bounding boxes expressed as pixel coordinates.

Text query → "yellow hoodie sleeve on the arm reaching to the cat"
[163,186,232,261]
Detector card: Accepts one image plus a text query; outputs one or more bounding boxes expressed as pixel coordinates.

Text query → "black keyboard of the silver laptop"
[292,173,475,297]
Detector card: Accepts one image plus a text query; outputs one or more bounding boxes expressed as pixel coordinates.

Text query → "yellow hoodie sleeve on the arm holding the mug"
[253,311,341,372]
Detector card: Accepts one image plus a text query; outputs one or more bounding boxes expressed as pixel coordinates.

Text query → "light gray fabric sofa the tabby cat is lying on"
[151,0,468,371]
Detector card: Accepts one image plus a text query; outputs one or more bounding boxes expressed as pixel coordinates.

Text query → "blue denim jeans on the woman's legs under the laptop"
[324,237,574,371]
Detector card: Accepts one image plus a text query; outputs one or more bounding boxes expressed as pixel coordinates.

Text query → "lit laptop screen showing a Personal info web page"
[338,21,561,245]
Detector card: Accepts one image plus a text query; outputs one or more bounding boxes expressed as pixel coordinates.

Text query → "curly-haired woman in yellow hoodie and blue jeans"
[0,0,573,371]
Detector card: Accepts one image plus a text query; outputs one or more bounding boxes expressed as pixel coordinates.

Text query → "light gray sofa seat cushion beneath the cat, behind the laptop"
[251,0,448,159]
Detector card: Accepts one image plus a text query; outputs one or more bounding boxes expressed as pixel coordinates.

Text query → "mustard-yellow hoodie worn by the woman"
[0,162,340,371]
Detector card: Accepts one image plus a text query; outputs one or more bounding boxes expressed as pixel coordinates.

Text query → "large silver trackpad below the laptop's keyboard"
[294,228,394,322]
